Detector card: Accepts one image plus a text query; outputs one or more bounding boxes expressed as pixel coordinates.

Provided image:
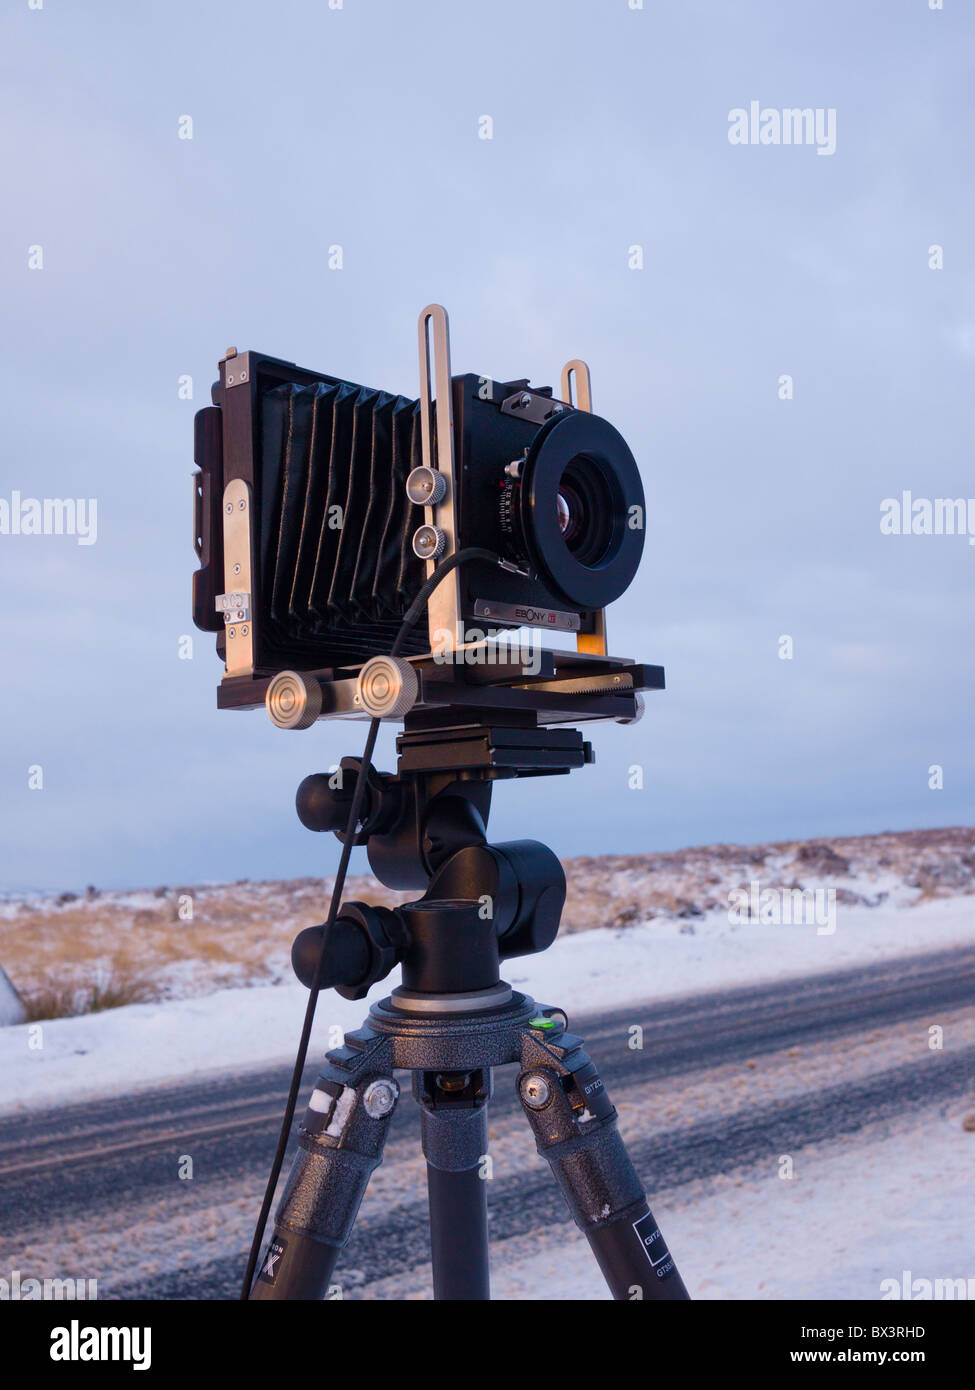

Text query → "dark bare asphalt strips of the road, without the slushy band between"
[0,947,975,1298]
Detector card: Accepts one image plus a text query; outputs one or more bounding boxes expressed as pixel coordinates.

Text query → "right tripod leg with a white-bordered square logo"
[517,1019,690,1300]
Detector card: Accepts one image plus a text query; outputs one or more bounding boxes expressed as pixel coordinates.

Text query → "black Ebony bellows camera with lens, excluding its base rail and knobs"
[193,306,662,717]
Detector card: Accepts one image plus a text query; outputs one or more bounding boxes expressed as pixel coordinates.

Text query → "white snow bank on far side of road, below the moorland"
[0,895,975,1109]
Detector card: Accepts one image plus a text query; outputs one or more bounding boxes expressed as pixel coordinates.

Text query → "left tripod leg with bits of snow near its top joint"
[250,1030,399,1300]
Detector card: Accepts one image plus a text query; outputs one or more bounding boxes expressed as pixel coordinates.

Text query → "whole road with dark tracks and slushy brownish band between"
[0,947,975,1298]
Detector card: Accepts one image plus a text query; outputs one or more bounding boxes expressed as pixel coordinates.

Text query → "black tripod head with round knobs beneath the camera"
[292,710,593,1009]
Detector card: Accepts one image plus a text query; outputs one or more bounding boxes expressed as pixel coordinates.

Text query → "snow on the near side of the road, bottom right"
[453,1111,975,1300]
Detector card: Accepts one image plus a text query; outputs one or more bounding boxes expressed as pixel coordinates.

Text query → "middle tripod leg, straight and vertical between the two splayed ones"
[413,1070,491,1301]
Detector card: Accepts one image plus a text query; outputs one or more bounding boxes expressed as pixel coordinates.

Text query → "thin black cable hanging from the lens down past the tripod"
[241,545,501,1301]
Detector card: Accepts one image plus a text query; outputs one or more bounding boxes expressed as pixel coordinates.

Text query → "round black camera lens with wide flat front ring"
[514,410,644,607]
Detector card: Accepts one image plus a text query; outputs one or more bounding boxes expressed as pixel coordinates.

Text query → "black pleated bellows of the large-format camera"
[259,381,427,663]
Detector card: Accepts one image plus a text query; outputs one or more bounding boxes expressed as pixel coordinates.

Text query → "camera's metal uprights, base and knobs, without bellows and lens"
[195,304,663,728]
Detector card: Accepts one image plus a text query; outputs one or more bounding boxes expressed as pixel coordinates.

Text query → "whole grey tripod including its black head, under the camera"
[250,710,688,1300]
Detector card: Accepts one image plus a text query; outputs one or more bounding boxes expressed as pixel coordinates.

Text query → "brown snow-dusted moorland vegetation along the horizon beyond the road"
[0,828,975,1017]
